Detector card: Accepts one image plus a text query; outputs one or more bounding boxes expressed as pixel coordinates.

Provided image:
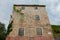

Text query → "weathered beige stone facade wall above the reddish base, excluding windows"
[8,6,53,40]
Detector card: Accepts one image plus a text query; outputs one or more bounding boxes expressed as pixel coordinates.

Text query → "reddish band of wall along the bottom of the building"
[6,36,53,40]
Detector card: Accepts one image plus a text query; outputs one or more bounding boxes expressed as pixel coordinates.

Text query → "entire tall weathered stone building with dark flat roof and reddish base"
[6,5,53,40]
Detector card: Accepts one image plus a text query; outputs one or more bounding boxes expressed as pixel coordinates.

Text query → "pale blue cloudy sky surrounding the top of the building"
[0,0,60,27]
